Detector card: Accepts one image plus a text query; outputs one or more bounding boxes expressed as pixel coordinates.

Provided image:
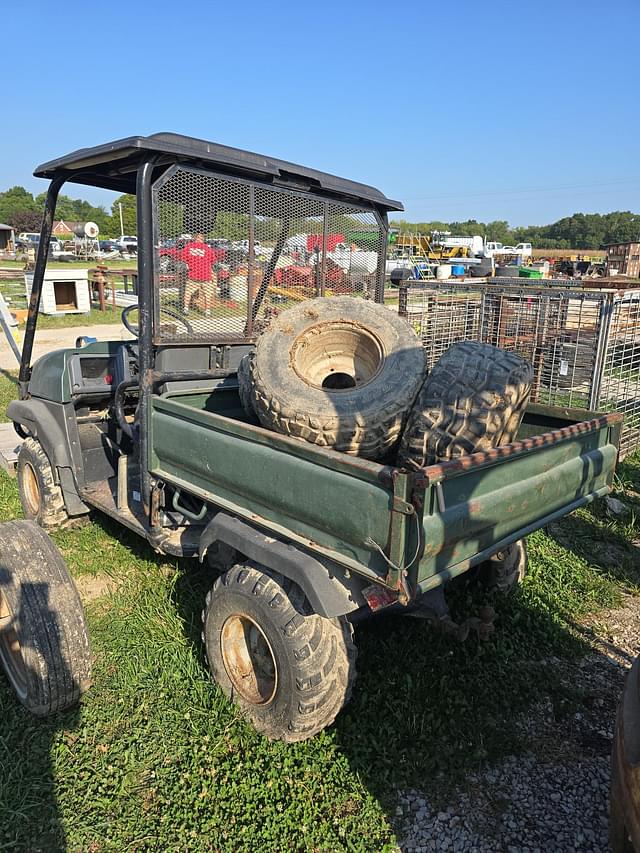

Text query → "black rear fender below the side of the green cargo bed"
[199,512,370,618]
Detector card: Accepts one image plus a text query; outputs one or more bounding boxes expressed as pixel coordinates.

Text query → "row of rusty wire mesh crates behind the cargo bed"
[399,281,640,456]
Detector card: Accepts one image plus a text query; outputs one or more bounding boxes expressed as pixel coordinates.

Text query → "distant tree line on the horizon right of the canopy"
[391,210,640,249]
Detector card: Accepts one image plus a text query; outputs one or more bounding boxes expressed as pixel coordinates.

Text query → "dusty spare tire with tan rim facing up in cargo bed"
[250,296,424,459]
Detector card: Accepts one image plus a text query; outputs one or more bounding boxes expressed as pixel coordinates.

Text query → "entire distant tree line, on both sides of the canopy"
[0,186,640,249]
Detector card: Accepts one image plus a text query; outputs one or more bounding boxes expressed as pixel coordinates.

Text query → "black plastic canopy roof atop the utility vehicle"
[34,133,404,211]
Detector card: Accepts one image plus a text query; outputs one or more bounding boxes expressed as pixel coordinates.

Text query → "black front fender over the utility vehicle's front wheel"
[7,397,89,515]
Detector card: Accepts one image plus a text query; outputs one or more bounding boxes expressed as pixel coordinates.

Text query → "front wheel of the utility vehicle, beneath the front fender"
[16,438,70,528]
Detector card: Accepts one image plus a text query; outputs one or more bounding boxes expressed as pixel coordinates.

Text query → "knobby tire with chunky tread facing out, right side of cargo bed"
[398,341,533,467]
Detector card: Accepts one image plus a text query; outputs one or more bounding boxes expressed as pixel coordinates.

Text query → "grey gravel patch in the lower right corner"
[396,596,640,853]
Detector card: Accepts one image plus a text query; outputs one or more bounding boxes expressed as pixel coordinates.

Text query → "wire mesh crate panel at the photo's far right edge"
[597,290,640,455]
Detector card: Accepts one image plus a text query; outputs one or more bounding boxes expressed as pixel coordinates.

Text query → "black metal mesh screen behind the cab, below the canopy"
[153,168,386,343]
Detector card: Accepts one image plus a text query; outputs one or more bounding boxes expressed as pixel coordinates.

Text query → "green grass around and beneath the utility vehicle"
[0,377,640,853]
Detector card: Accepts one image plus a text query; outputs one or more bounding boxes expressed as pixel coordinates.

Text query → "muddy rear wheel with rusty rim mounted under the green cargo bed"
[203,562,356,743]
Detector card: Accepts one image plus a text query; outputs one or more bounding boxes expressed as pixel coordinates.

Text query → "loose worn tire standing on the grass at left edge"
[0,521,91,717]
